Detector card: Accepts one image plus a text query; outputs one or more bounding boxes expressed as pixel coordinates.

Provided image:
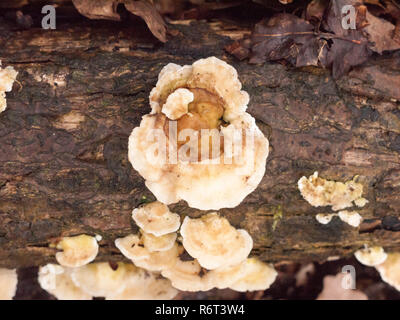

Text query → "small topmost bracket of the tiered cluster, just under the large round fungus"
[132,201,181,237]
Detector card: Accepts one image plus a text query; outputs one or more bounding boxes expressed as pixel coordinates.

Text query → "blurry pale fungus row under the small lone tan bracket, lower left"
[38,262,177,300]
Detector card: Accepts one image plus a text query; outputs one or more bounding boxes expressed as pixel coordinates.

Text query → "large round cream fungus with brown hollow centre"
[128,57,269,210]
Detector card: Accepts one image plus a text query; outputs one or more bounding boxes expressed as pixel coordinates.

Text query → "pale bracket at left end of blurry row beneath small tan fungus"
[38,264,93,300]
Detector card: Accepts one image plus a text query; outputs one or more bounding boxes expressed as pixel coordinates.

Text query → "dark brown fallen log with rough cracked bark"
[0,5,400,268]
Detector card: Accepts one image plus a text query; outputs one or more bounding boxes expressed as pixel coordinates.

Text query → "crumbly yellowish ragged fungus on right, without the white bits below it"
[298,172,368,211]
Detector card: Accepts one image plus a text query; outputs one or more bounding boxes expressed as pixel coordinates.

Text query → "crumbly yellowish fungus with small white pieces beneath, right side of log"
[297,172,368,227]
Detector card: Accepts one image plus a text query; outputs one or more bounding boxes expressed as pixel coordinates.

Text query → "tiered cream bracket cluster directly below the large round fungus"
[115,202,277,291]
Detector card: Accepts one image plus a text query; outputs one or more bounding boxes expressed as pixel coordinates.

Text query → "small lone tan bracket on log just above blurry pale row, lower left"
[51,234,99,268]
